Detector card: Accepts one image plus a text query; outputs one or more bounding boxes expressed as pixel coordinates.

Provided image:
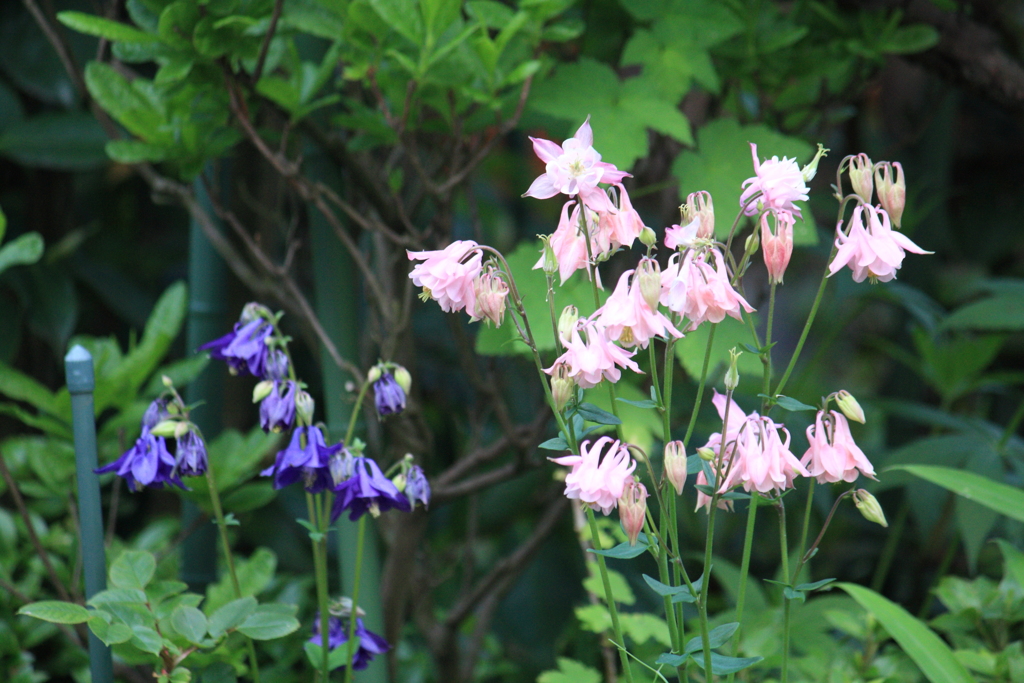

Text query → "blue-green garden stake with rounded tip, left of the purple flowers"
[65,345,114,683]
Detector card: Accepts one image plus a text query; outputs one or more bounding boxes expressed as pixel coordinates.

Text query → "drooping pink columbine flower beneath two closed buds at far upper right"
[828,204,932,283]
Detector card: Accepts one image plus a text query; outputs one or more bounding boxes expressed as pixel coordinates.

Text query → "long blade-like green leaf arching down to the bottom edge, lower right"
[838,583,974,683]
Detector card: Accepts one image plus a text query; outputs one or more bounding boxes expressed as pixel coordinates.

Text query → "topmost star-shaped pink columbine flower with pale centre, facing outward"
[523,117,629,212]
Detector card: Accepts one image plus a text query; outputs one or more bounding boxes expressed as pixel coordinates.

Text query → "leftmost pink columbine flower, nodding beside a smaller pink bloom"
[406,240,483,317]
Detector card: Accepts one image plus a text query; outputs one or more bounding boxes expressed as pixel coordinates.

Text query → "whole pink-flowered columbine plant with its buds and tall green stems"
[407,121,928,682]
